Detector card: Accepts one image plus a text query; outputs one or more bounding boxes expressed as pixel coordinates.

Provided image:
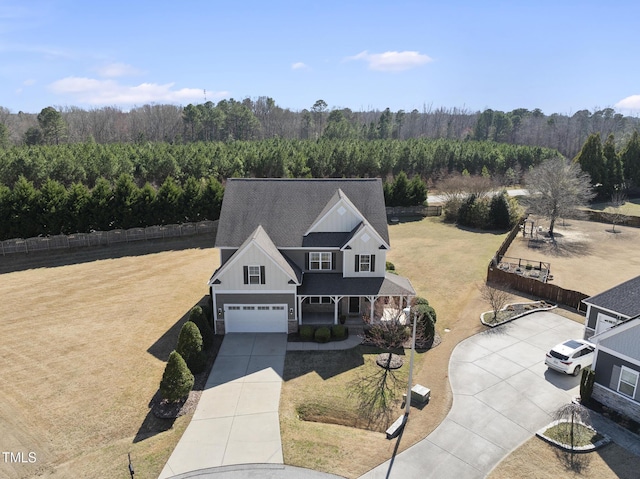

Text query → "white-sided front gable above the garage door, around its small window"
[214,244,295,292]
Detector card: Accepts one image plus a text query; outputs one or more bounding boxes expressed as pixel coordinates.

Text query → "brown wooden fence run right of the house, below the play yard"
[487,260,589,311]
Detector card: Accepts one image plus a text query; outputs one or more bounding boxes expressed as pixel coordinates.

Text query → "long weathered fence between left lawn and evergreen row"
[0,220,218,256]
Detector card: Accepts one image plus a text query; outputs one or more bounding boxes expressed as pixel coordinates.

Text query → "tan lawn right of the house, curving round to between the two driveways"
[280,218,505,478]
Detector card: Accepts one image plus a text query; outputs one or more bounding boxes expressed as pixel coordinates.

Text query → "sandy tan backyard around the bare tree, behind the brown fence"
[505,217,640,296]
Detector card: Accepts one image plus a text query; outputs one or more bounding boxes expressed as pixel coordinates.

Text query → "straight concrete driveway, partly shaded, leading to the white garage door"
[160,334,287,479]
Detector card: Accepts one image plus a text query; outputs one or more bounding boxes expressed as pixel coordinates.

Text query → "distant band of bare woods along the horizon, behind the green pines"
[0,97,640,158]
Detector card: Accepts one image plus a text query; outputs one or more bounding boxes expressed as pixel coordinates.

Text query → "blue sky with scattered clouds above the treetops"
[0,0,640,116]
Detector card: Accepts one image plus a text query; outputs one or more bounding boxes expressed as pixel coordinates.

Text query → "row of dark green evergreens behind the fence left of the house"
[0,174,224,240]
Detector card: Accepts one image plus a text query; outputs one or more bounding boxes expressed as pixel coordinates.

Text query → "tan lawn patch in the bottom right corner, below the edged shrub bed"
[488,437,640,479]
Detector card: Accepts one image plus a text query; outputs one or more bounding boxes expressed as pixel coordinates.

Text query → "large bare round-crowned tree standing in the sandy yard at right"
[525,157,595,239]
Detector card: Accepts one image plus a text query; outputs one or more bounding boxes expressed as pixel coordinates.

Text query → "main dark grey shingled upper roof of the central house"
[216,178,389,248]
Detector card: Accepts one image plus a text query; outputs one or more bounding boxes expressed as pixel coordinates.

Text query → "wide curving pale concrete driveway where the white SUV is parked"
[362,312,584,479]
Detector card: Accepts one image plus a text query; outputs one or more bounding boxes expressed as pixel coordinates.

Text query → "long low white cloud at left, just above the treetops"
[49,77,228,105]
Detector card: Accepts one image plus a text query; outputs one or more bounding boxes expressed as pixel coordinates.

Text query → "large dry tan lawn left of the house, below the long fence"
[0,238,218,479]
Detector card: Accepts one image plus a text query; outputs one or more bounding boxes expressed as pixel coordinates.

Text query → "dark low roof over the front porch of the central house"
[298,273,416,296]
